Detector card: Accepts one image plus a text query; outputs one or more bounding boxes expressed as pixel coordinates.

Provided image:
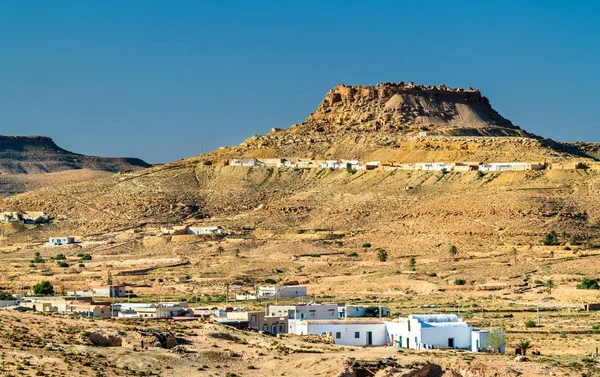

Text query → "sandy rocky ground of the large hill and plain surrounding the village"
[0,84,600,377]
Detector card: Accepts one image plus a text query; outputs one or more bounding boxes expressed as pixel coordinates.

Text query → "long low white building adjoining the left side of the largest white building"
[295,320,386,346]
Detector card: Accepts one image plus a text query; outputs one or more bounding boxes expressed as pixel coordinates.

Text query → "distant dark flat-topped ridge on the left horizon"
[0,136,150,174]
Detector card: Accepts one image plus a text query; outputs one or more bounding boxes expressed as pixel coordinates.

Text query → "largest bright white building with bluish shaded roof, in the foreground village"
[386,314,472,349]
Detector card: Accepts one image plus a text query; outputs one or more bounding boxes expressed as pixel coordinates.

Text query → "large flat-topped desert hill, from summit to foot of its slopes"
[0,84,600,236]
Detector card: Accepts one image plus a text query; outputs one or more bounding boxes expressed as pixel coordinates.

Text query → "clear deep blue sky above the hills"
[0,0,600,162]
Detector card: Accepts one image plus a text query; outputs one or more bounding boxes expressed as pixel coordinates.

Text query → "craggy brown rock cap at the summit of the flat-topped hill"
[305,83,530,136]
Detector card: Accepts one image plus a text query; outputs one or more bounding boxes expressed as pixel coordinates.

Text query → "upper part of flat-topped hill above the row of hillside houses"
[211,82,597,162]
